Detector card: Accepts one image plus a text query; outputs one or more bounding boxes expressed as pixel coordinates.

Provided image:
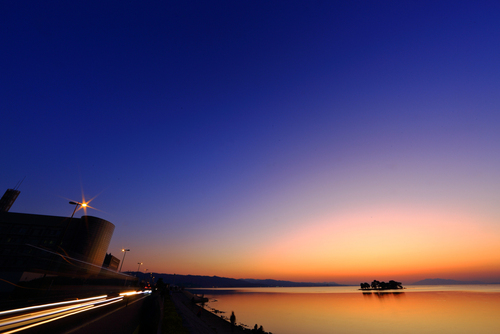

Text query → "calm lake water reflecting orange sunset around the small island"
[193,285,500,334]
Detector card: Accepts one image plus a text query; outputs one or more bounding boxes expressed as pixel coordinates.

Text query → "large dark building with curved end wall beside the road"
[0,212,115,291]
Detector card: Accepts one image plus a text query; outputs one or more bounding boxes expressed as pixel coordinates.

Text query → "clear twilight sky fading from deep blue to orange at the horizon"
[0,0,500,283]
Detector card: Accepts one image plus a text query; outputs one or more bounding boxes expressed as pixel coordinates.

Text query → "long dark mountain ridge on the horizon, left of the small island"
[127,271,341,288]
